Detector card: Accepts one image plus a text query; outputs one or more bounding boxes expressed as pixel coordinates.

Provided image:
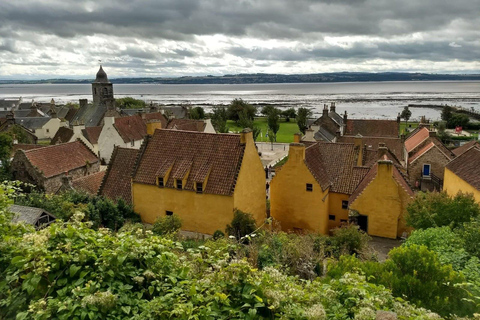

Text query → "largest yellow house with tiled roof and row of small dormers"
[132,129,266,234]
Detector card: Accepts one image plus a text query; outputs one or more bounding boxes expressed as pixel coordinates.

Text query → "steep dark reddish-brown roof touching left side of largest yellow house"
[98,147,139,204]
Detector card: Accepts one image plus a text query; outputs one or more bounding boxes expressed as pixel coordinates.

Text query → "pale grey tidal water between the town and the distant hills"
[0,81,480,120]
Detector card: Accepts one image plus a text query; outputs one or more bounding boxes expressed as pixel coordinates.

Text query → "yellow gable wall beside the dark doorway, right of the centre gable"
[350,161,411,238]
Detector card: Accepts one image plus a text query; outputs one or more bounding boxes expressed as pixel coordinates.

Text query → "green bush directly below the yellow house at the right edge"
[405,192,480,229]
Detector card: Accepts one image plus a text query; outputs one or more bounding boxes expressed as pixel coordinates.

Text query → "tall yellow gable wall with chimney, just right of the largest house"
[270,144,329,234]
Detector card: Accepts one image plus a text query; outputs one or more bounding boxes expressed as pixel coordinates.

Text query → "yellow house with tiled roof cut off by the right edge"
[443,144,480,203]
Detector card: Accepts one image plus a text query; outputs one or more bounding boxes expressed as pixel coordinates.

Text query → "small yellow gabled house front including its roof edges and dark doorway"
[349,157,413,239]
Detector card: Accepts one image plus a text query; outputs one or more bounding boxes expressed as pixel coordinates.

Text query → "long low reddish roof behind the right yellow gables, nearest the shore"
[344,119,400,137]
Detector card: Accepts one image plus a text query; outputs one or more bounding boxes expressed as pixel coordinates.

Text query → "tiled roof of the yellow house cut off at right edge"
[446,146,480,190]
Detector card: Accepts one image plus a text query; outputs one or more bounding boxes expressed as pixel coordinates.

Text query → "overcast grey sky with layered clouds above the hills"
[0,0,480,79]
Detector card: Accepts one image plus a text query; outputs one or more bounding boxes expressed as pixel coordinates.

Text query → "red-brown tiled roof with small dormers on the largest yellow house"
[133,129,245,195]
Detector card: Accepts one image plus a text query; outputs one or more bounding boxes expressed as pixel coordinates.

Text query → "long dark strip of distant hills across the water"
[0,72,480,84]
